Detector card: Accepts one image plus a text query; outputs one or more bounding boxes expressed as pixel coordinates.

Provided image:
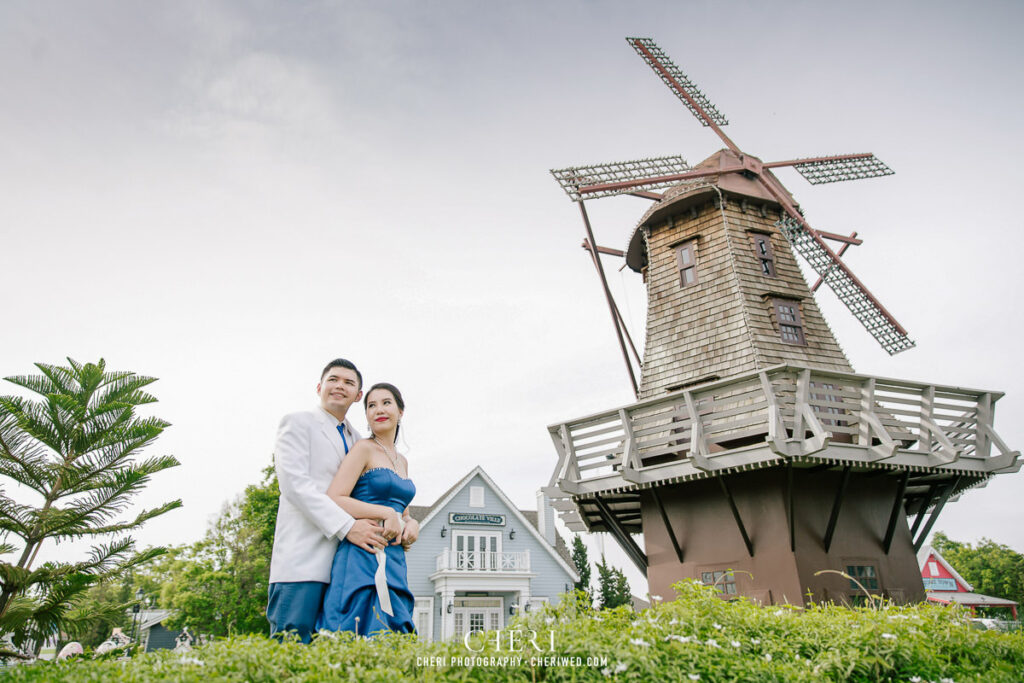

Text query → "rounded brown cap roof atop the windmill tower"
[626,150,796,272]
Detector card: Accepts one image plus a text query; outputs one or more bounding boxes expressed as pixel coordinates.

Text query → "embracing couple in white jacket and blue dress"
[266,358,420,643]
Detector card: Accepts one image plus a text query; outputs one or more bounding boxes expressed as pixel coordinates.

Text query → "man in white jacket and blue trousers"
[266,358,419,643]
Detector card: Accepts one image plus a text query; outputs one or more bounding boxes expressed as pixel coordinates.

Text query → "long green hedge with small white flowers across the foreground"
[7,582,1024,683]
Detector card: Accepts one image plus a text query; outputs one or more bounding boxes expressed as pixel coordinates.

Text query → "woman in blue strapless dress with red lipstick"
[316,382,416,636]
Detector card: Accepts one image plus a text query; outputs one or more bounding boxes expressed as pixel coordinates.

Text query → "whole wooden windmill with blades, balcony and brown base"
[548,38,1020,604]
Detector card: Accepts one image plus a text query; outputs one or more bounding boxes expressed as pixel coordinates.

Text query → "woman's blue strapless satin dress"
[316,467,416,636]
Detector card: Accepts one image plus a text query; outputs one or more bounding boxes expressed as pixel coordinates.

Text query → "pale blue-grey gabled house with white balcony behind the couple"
[407,467,579,640]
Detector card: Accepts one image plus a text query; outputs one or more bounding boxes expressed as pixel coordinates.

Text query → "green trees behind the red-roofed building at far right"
[932,531,1024,604]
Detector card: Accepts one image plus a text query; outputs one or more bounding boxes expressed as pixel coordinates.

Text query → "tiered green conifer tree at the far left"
[0,358,181,655]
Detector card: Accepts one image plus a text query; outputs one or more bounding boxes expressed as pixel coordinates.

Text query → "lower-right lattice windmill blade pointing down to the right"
[775,217,914,355]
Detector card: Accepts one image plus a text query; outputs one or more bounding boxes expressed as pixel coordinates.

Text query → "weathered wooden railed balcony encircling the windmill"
[546,365,1021,530]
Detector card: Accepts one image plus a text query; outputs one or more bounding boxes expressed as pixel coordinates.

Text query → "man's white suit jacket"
[270,407,359,584]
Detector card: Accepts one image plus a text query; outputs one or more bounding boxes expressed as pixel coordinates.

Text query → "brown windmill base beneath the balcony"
[641,466,925,606]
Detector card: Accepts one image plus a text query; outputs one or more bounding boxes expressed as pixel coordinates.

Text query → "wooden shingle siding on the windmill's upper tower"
[640,187,853,398]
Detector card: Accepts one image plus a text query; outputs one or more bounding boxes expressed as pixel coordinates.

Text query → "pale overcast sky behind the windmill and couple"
[0,0,1024,587]
